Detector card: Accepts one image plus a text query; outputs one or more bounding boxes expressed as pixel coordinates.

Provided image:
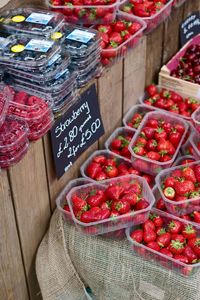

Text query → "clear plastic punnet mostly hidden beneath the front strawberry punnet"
[56,178,94,222]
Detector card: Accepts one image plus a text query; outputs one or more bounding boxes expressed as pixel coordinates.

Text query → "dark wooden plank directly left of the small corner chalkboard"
[162,6,183,65]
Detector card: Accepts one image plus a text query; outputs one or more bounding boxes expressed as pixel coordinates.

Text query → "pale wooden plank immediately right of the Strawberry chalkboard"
[98,61,123,148]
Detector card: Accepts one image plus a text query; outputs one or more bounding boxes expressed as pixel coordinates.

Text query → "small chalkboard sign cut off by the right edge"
[180,11,200,47]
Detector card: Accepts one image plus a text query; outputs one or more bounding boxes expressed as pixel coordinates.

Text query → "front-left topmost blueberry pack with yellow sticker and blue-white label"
[0,34,61,70]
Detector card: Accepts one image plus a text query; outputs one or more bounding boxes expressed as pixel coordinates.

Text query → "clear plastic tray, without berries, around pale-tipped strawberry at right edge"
[156,160,200,216]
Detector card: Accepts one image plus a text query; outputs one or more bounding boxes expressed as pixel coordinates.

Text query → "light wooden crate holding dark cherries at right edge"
[159,34,200,98]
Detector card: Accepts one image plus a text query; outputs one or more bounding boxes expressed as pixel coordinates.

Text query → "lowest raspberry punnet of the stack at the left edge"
[0,139,29,169]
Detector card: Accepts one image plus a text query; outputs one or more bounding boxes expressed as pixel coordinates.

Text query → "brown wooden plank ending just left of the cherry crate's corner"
[146,24,164,85]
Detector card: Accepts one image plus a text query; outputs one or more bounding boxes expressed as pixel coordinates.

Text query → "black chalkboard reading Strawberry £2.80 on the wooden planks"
[51,84,104,178]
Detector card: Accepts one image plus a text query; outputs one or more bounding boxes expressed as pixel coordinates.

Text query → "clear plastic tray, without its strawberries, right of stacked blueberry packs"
[101,11,146,66]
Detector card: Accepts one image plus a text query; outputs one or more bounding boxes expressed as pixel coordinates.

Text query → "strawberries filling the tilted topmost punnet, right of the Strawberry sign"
[131,112,187,162]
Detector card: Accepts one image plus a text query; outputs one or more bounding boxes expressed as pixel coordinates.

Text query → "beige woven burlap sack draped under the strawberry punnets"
[36,212,200,300]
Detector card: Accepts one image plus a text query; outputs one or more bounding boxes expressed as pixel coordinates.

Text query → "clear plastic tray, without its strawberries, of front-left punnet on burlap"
[67,175,155,235]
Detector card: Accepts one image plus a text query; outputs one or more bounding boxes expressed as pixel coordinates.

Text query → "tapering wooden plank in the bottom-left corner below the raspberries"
[0,171,29,300]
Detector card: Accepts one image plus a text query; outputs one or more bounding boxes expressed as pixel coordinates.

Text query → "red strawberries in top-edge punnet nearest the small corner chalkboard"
[121,0,169,18]
